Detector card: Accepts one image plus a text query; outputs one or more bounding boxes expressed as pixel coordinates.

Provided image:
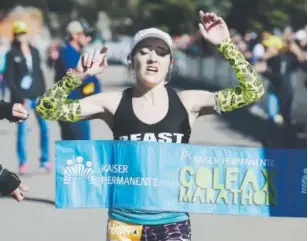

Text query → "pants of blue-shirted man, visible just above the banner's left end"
[59,120,90,140]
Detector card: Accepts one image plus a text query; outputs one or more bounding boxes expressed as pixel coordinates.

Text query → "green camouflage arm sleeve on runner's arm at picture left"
[35,73,82,122]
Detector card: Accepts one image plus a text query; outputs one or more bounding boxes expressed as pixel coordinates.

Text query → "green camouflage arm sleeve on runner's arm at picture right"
[214,38,264,113]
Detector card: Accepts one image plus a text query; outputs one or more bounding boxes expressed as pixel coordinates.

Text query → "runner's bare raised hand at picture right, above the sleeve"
[199,11,230,45]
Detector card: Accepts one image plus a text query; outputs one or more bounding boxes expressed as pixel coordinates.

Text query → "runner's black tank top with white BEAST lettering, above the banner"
[112,87,191,143]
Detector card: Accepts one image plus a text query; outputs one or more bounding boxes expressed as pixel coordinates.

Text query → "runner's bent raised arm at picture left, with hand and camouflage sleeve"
[35,49,113,122]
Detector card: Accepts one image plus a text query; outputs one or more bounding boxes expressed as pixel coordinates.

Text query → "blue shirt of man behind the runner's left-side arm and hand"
[55,43,101,99]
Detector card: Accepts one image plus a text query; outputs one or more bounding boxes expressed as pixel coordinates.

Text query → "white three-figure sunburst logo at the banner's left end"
[64,156,95,185]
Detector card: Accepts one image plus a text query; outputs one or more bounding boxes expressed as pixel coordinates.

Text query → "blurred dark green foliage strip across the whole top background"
[0,0,307,35]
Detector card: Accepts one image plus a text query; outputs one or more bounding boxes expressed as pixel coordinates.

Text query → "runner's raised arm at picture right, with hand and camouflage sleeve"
[180,12,264,114]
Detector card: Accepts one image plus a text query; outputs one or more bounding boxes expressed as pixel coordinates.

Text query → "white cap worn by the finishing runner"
[130,28,173,57]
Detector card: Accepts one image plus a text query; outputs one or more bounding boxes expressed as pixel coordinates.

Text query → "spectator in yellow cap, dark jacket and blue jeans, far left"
[5,21,51,174]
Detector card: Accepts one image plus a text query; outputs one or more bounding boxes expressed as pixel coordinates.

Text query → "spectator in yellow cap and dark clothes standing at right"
[255,28,296,148]
